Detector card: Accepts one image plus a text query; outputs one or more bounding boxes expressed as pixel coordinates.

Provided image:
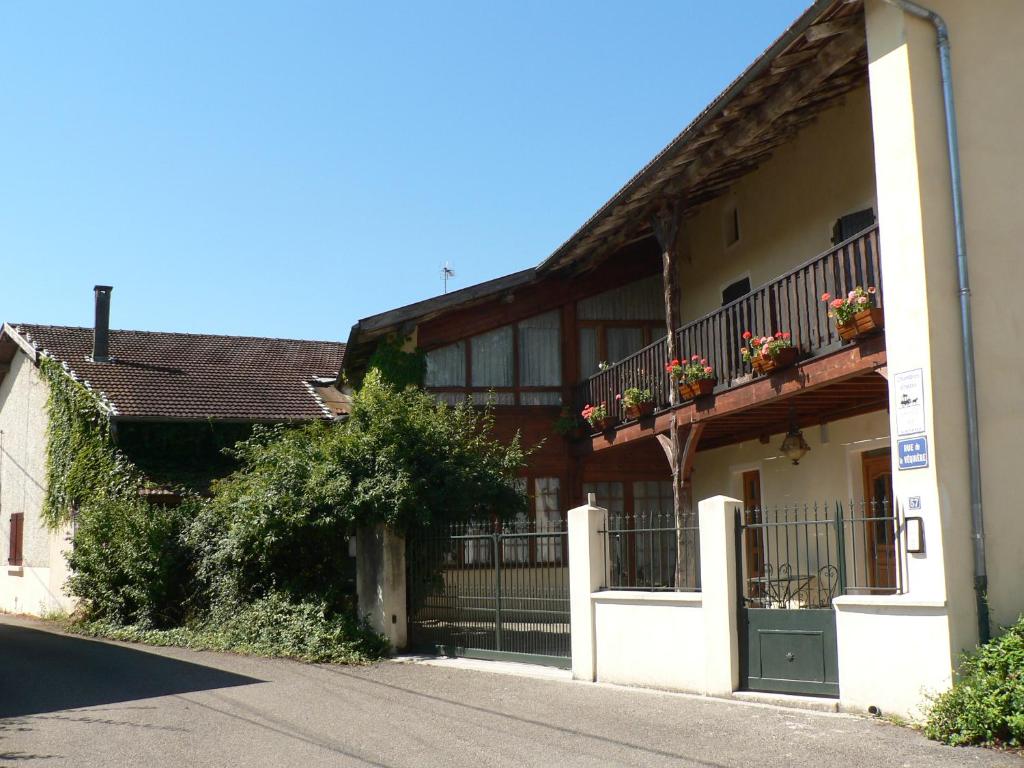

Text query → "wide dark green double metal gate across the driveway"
[406,520,571,669]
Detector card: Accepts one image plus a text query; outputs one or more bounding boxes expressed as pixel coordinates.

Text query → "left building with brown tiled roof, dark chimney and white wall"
[0,286,345,614]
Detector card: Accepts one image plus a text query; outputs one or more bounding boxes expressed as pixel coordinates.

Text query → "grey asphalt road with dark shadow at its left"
[0,617,1024,768]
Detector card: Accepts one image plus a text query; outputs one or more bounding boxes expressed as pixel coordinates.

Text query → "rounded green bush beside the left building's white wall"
[68,498,202,628]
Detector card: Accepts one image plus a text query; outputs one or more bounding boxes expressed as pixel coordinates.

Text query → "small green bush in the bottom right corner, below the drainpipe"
[925,616,1024,746]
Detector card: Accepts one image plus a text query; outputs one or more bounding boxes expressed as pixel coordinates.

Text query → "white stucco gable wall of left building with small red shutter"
[0,352,72,614]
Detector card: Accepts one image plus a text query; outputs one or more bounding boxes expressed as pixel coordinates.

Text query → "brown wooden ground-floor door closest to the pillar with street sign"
[862,449,896,594]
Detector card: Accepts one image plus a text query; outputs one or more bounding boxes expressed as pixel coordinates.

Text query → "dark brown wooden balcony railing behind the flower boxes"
[575,224,882,417]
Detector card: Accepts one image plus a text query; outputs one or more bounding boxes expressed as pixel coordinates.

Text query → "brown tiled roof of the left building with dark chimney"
[11,324,345,421]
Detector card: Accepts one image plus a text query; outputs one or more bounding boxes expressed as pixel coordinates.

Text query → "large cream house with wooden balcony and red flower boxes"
[345,0,1024,715]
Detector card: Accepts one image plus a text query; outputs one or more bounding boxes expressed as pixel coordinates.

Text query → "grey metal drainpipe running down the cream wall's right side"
[885,0,991,643]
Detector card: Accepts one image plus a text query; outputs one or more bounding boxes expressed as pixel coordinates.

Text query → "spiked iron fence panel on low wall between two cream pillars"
[600,512,700,592]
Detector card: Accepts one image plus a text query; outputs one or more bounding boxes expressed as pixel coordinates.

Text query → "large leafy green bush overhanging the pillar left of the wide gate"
[201,372,526,610]
